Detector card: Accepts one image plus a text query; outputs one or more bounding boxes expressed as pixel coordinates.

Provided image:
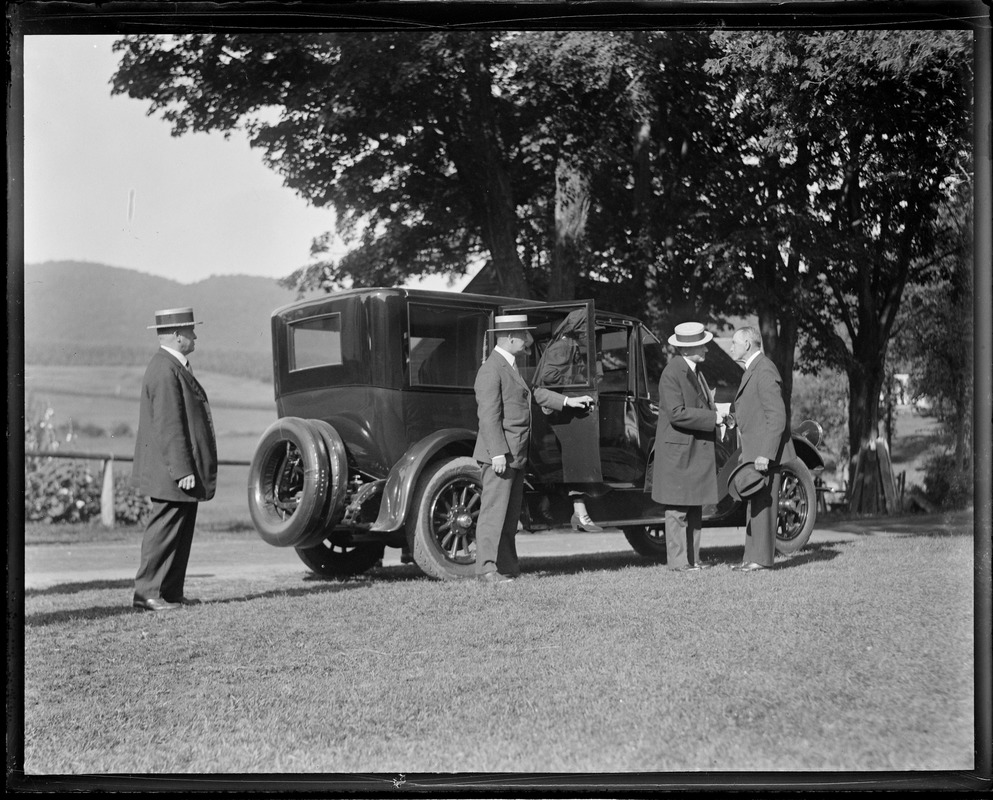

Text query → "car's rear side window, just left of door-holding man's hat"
[407,303,490,389]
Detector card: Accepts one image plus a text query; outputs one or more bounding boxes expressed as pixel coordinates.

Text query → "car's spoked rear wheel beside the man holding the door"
[407,457,483,580]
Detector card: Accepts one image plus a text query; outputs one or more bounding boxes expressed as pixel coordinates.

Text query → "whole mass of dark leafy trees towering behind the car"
[112,30,971,472]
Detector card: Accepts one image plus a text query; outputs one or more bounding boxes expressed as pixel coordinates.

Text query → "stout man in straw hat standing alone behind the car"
[131,308,217,611]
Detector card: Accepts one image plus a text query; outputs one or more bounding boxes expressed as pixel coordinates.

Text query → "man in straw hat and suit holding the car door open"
[473,314,593,583]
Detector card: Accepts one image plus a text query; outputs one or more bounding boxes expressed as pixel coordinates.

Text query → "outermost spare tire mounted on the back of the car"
[248,417,329,547]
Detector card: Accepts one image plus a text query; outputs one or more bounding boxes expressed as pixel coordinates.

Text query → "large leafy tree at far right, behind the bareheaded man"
[710,30,971,457]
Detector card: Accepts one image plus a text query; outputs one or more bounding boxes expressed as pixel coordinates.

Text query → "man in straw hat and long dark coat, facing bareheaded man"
[652,322,724,572]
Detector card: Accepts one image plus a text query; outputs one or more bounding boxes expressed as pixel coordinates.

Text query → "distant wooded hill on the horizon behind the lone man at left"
[24,261,314,380]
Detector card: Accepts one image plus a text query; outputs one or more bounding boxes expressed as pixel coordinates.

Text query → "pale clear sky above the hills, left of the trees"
[24,35,472,288]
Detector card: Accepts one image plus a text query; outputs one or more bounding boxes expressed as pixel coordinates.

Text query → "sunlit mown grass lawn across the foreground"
[24,528,974,779]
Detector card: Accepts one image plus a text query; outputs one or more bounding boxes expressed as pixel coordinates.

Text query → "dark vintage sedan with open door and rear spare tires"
[248,288,823,579]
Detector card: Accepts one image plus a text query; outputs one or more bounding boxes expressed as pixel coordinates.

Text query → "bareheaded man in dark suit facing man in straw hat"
[731,327,796,572]
